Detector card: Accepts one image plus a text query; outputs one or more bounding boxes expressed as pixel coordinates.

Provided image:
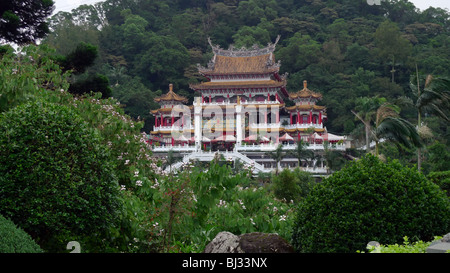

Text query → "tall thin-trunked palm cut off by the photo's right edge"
[410,69,450,171]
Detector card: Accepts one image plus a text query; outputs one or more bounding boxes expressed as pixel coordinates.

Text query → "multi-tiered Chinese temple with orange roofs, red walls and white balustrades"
[150,37,349,175]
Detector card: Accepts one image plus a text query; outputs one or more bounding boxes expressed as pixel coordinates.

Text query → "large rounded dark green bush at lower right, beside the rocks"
[292,155,450,253]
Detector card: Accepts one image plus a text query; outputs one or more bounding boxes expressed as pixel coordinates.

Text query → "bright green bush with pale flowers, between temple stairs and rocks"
[137,162,293,252]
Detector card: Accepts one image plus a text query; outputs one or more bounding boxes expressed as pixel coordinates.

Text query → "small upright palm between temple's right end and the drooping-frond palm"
[351,97,386,152]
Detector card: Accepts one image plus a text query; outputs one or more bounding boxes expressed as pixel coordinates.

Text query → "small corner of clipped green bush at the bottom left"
[0,215,42,253]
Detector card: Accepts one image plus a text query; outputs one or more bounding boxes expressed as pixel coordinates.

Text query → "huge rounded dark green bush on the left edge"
[0,101,120,252]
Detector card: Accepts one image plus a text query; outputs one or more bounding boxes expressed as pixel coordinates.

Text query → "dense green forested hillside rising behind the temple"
[44,0,450,169]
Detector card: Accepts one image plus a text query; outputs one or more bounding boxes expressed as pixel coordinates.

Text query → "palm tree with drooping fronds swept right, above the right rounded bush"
[372,102,422,156]
